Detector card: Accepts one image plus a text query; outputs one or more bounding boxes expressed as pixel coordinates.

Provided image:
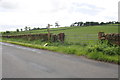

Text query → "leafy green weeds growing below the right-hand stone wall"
[87,42,120,55]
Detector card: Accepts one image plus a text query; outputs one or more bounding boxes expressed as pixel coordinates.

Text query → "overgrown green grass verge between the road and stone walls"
[2,38,120,64]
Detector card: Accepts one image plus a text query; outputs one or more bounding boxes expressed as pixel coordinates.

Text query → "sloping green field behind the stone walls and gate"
[3,25,118,43]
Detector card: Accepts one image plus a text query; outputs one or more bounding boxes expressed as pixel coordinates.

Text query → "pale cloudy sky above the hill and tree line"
[0,0,119,31]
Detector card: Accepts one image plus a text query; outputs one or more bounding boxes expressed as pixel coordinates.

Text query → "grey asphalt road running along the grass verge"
[0,43,118,78]
